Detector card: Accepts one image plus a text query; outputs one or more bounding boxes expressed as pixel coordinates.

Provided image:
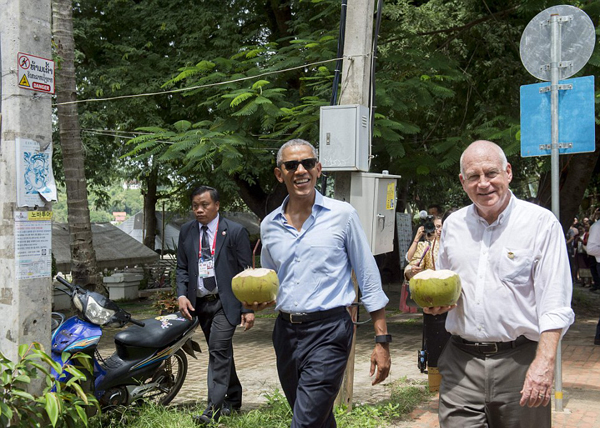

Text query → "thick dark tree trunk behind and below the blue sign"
[538,125,600,232]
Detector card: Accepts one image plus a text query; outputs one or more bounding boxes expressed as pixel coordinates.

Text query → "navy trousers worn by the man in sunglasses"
[273,312,354,428]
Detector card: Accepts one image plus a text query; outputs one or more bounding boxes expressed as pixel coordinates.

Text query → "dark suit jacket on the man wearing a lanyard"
[177,216,252,325]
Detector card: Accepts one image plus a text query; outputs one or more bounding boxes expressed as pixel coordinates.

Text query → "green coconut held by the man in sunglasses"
[231,268,279,303]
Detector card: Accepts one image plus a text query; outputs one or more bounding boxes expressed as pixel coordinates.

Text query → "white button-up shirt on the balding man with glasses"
[438,193,574,342]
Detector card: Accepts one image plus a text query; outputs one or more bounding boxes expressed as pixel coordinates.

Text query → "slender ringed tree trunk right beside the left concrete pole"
[52,0,105,293]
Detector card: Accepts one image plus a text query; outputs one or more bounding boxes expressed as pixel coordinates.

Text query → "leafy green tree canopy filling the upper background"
[62,0,600,231]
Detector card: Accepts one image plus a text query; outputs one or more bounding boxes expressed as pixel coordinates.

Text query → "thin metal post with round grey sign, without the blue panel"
[520,5,595,412]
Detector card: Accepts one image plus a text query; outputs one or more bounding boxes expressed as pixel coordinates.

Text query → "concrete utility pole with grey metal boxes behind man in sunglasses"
[335,0,375,408]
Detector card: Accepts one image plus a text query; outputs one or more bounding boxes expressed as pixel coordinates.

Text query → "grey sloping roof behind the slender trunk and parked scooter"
[52,222,159,272]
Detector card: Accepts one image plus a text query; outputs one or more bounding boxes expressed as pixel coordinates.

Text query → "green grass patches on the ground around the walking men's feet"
[90,378,431,428]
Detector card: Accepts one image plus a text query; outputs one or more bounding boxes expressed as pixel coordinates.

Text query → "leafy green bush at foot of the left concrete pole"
[0,343,100,428]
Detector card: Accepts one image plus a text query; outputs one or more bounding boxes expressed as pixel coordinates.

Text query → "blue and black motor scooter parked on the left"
[52,277,200,408]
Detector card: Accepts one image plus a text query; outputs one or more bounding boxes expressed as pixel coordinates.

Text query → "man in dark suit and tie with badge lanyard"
[177,186,254,425]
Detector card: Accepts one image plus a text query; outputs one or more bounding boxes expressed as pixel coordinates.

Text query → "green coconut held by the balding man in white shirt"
[409,269,461,308]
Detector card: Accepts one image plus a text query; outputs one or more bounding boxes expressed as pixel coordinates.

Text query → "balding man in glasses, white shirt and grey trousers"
[423,141,574,428]
